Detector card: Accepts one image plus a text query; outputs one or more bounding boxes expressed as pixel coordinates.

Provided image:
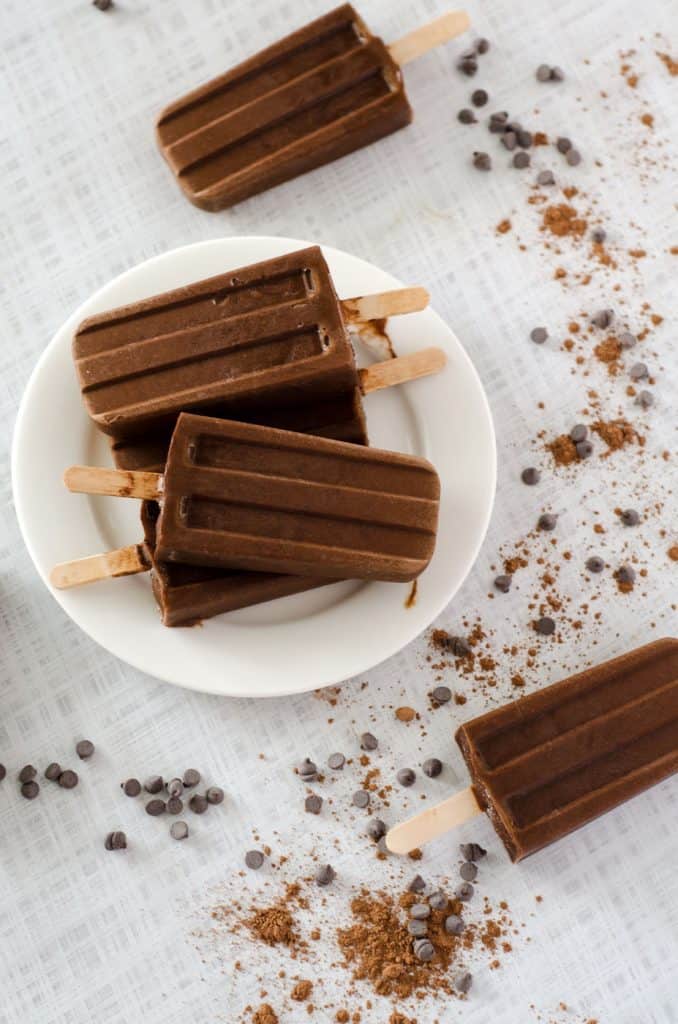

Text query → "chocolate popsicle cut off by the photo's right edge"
[386,639,678,860]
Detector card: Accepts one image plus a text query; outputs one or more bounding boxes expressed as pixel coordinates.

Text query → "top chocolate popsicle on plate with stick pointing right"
[73,246,428,440]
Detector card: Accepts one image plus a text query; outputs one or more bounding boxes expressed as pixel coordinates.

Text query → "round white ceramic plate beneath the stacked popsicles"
[12,238,496,696]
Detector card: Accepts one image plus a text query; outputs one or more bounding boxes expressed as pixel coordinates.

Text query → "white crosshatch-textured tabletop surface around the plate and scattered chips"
[0,0,678,1024]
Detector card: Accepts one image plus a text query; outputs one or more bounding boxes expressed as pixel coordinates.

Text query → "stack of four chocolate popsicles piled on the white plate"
[52,247,444,626]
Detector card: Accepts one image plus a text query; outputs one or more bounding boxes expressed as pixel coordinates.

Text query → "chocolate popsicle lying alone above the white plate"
[157,4,469,210]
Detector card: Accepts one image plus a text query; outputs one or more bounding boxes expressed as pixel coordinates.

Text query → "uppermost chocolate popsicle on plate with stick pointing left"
[65,413,439,582]
